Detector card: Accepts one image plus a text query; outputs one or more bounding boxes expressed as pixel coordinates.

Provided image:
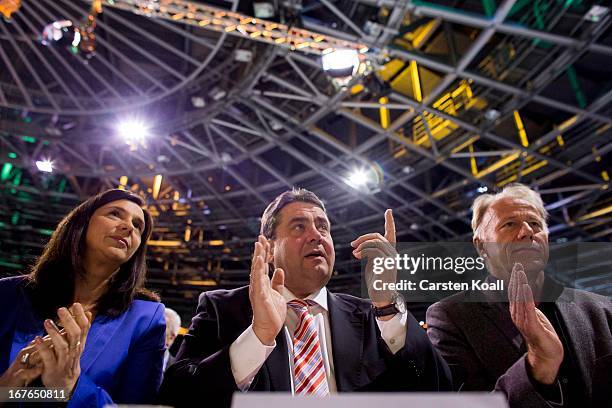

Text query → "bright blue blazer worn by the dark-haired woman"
[0,276,166,407]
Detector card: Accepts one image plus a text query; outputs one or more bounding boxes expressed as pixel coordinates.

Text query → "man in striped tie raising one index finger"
[161,189,450,407]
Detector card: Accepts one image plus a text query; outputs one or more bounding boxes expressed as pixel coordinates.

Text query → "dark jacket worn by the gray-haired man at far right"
[427,288,612,407]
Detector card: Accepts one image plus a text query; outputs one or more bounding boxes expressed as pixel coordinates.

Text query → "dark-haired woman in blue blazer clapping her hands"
[0,190,165,407]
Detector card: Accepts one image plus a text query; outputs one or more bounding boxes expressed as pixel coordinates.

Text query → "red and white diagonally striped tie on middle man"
[287,299,329,397]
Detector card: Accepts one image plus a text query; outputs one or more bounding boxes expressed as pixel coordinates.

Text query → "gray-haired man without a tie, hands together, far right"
[427,184,612,408]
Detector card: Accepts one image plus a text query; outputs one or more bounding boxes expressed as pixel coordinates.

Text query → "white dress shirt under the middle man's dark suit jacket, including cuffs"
[229,287,407,394]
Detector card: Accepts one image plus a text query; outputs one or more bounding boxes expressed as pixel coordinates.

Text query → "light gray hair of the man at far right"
[472,183,548,235]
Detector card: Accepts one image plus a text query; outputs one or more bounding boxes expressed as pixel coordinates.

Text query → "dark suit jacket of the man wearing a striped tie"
[161,287,451,407]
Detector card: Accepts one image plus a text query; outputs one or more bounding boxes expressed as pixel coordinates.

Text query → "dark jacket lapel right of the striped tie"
[327,292,366,392]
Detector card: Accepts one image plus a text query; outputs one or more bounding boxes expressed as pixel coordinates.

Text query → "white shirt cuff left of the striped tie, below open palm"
[229,325,276,391]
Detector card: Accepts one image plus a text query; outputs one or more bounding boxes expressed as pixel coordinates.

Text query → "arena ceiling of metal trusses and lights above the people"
[0,0,612,315]
